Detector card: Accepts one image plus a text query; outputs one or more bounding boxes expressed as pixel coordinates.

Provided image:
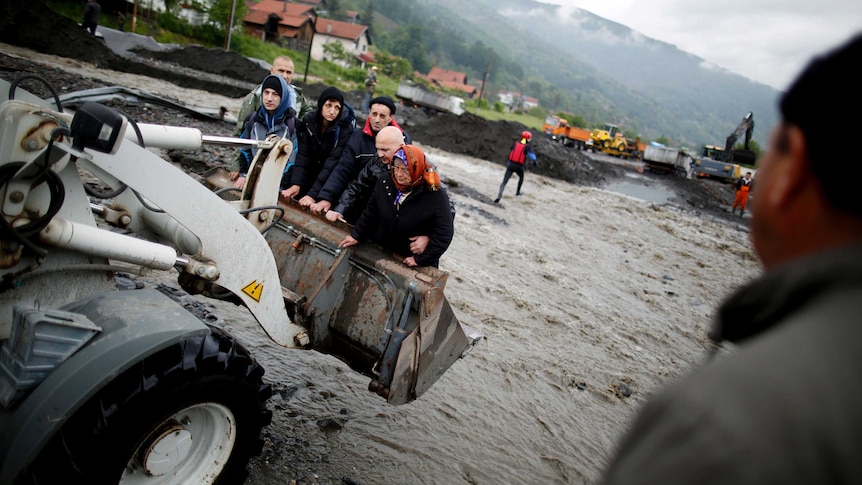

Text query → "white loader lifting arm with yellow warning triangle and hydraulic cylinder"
[0,101,307,347]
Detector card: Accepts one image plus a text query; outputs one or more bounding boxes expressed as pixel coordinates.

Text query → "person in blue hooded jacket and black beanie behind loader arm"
[231,74,296,189]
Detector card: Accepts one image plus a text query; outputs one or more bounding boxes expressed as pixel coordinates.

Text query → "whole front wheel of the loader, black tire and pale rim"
[17,327,272,484]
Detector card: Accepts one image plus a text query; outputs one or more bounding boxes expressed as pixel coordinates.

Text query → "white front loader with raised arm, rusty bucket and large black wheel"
[0,74,482,484]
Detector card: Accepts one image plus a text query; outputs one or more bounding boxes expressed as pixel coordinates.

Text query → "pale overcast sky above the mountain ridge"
[544,0,862,91]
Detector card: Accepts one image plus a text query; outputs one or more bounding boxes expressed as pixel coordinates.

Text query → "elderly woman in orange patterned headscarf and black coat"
[338,145,455,268]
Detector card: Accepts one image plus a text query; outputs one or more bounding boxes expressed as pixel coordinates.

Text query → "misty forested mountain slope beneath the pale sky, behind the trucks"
[408,0,780,147]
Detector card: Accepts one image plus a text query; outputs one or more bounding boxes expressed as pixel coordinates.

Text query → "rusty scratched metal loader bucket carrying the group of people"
[205,170,482,404]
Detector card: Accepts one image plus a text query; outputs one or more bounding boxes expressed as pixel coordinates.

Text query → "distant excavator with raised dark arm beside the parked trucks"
[693,112,756,182]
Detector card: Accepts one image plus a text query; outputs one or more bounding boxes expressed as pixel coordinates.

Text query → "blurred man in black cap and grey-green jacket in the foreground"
[604,35,862,485]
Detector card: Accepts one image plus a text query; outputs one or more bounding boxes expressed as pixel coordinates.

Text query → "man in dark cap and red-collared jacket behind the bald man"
[299,96,410,214]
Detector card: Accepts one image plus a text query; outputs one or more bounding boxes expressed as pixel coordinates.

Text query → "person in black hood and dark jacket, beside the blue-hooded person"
[281,86,356,199]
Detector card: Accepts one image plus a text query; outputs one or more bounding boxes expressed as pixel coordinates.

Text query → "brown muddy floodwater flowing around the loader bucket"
[170,150,759,484]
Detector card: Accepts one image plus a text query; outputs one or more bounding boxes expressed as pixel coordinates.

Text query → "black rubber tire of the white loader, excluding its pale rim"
[18,328,272,484]
